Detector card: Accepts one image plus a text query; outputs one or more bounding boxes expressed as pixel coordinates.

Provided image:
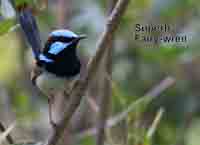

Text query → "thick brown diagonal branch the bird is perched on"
[46,0,129,145]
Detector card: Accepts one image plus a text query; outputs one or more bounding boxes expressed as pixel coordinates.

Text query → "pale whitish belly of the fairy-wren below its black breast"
[36,72,72,96]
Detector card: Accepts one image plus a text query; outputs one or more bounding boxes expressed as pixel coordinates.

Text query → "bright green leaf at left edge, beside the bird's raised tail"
[0,19,17,36]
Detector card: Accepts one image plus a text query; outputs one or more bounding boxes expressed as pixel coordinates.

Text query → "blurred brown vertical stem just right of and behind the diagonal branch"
[96,0,116,145]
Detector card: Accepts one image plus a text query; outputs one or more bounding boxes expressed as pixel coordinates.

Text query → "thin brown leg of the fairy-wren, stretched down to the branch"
[48,94,56,128]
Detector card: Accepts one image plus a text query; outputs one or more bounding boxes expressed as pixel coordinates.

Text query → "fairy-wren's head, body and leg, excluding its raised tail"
[31,29,86,126]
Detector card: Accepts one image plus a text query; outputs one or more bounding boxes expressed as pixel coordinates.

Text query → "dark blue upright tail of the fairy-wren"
[19,8,41,60]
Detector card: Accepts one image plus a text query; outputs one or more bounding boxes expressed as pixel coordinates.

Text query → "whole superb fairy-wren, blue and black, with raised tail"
[19,6,86,124]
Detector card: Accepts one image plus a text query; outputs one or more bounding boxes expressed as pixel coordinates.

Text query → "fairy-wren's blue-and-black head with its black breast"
[37,29,86,76]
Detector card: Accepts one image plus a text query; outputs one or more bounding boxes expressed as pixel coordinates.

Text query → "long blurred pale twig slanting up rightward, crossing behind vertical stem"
[76,77,175,138]
